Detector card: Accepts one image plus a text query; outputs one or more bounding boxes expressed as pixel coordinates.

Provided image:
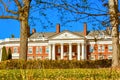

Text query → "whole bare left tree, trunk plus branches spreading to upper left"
[0,0,31,60]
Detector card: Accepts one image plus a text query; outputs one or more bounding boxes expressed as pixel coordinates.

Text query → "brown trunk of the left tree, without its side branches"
[19,0,31,60]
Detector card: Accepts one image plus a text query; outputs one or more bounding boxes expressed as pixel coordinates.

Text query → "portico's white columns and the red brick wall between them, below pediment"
[48,40,86,60]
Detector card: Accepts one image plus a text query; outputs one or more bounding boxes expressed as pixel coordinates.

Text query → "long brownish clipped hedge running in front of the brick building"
[0,60,111,69]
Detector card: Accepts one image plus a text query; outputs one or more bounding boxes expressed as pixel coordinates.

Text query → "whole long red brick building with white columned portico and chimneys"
[0,23,112,60]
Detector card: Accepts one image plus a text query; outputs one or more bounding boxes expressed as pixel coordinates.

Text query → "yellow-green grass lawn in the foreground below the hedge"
[0,68,120,80]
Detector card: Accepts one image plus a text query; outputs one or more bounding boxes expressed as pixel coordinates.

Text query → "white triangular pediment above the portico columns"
[51,31,82,39]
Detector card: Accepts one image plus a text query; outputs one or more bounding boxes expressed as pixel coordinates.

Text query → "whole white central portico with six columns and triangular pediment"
[48,31,86,60]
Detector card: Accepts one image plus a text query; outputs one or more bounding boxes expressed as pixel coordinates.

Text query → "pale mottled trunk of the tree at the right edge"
[109,0,120,67]
